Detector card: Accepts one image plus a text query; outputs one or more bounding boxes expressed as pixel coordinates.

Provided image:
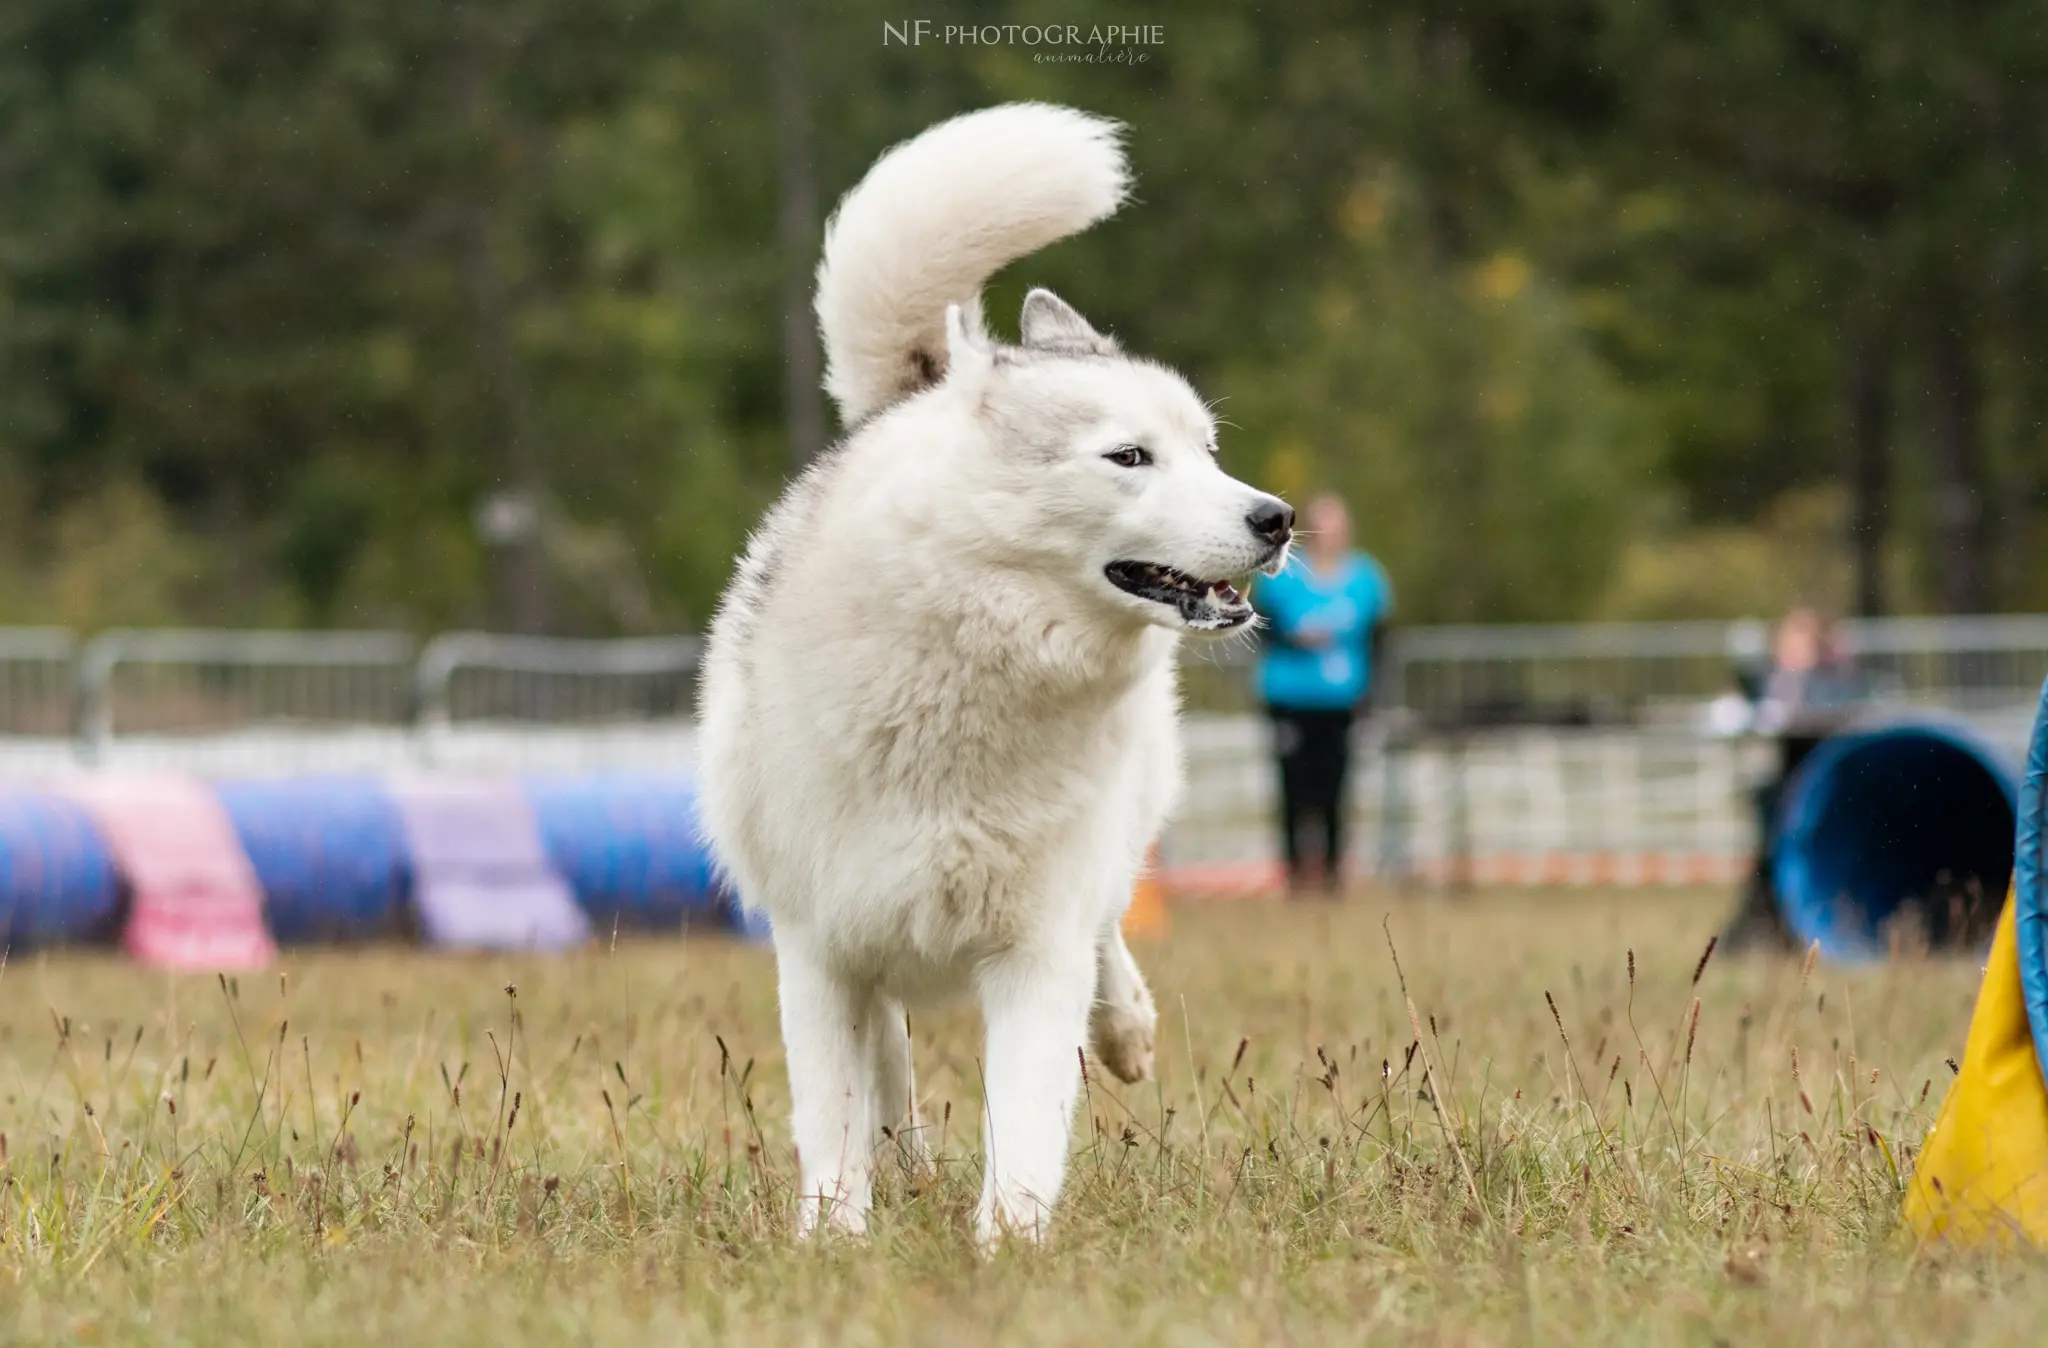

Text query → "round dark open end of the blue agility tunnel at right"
[1772,719,2040,959]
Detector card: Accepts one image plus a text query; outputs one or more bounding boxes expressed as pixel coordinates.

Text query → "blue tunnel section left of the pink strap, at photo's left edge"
[0,793,121,949]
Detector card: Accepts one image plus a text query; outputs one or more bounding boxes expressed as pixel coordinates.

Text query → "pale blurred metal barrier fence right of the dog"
[1167,617,2048,881]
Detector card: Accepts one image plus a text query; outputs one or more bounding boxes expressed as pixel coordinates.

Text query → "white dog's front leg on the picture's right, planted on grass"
[975,942,1096,1248]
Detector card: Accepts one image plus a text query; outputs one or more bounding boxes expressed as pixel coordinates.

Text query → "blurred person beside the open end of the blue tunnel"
[1722,604,1866,949]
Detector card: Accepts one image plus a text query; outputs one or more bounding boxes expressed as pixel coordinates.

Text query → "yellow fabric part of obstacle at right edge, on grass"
[1905,897,2048,1250]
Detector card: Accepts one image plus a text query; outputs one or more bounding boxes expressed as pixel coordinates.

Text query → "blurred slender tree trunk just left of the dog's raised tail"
[768,14,825,471]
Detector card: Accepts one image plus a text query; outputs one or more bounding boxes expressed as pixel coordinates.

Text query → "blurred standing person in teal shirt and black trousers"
[1251,494,1393,895]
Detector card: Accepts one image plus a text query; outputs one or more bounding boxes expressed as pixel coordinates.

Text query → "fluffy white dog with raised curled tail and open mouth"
[700,104,1292,1244]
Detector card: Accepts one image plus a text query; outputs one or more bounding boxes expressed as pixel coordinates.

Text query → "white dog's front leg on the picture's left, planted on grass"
[776,944,874,1235]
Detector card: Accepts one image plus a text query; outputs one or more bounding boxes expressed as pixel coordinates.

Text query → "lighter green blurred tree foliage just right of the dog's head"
[1227,197,1649,621]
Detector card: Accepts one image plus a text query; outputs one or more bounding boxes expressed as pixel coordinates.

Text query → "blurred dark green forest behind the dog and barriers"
[0,0,2048,633]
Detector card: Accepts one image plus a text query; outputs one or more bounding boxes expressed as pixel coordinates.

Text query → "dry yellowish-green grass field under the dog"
[0,893,2048,1346]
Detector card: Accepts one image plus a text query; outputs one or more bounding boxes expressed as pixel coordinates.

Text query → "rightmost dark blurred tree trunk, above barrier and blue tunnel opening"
[1927,303,1989,613]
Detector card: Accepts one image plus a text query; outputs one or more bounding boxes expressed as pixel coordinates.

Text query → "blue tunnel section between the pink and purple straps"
[215,776,412,942]
